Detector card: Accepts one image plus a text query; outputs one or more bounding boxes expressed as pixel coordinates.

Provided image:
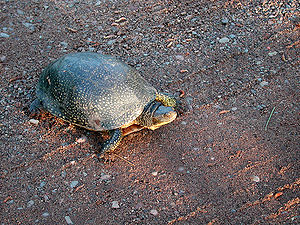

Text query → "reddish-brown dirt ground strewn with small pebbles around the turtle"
[0,0,300,225]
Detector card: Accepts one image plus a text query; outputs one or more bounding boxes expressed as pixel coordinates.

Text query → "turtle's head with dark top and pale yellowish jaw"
[139,101,177,130]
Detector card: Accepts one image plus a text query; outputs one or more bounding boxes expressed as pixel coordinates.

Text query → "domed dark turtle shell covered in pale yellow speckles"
[36,52,157,131]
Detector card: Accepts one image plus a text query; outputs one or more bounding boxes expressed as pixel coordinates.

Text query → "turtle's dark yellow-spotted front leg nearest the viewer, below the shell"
[97,128,123,157]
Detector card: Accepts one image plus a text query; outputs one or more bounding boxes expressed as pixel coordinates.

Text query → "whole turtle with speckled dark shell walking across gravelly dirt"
[30,52,179,157]
